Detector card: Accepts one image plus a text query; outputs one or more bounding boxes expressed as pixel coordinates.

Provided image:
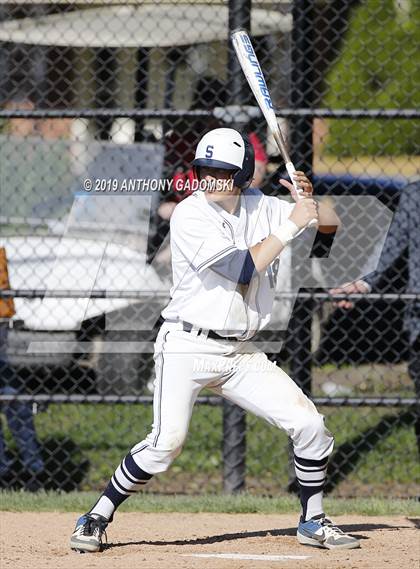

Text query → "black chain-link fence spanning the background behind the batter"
[0,0,420,497]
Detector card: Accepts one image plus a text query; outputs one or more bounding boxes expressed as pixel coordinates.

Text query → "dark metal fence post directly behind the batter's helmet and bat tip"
[223,0,251,494]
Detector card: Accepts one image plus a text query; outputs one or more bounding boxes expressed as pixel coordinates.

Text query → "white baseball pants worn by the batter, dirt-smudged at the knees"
[131,322,334,475]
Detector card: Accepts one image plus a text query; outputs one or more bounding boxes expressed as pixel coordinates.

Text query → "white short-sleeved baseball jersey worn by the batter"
[162,188,302,340]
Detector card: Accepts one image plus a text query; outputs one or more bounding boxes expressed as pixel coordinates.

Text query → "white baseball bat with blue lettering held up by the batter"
[231,30,317,226]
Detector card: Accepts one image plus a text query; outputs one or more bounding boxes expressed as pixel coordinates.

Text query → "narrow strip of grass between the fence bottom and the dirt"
[0,491,420,516]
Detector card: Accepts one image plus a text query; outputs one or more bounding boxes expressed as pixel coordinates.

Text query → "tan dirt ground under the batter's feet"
[0,512,420,569]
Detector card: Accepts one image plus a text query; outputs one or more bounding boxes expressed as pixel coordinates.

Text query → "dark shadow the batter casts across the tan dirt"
[104,523,406,549]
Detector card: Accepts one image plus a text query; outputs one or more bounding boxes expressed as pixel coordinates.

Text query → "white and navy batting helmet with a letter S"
[192,128,255,189]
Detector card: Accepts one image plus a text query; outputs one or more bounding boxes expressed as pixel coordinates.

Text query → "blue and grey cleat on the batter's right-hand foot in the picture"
[297,514,360,549]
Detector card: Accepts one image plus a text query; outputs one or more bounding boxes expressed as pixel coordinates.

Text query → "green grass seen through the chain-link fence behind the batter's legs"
[2,404,420,497]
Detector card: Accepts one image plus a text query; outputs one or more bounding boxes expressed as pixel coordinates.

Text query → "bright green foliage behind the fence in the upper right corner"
[325,0,420,156]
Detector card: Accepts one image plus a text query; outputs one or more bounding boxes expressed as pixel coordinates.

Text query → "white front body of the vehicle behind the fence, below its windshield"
[2,236,168,395]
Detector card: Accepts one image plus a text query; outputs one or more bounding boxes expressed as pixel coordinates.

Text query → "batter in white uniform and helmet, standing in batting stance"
[70,128,359,552]
